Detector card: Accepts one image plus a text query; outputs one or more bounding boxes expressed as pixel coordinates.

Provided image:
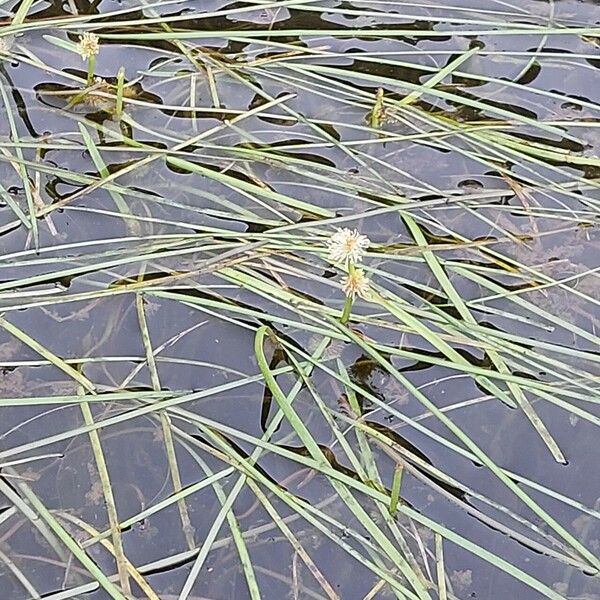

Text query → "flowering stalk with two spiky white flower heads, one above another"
[328,228,371,324]
